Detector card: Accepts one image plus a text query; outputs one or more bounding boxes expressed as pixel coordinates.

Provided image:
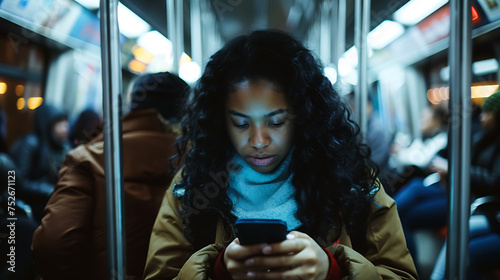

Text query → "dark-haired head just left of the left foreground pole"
[69,109,102,147]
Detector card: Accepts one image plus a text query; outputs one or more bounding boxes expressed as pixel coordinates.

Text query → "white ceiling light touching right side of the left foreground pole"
[118,3,151,38]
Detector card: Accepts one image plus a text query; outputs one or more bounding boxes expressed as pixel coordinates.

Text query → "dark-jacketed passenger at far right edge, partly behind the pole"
[431,92,500,280]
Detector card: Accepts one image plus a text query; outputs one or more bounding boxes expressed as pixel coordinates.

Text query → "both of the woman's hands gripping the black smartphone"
[224,231,330,280]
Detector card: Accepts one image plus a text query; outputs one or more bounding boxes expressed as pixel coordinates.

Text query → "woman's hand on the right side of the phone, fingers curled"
[240,231,330,280]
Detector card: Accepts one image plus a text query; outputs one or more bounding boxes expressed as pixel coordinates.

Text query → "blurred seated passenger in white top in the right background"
[385,102,449,193]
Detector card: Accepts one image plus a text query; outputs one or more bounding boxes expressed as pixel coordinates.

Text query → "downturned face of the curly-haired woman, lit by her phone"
[226,80,294,173]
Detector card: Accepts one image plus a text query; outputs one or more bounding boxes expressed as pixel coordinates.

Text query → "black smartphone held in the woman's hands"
[234,219,287,245]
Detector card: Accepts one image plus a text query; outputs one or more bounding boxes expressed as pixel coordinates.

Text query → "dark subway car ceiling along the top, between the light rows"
[121,0,408,56]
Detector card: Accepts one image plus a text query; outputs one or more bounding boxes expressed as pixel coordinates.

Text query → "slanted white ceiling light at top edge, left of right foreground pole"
[393,0,448,25]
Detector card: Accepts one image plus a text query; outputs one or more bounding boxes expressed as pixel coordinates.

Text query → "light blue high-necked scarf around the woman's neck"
[227,152,302,231]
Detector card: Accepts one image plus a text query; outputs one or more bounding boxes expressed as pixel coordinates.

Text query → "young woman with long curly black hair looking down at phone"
[145,31,417,279]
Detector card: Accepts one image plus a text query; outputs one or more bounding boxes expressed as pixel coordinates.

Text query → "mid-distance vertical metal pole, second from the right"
[354,0,371,138]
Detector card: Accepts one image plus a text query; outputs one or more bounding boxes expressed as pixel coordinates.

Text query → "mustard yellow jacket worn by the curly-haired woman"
[144,172,418,280]
